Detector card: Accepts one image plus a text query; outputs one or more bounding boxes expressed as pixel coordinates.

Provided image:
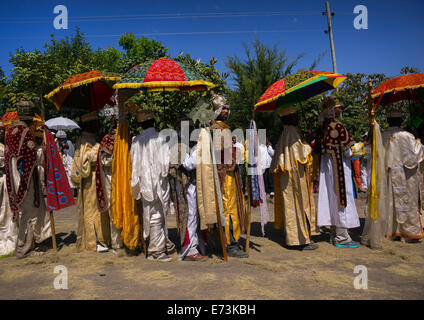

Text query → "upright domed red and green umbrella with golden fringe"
[113,58,215,91]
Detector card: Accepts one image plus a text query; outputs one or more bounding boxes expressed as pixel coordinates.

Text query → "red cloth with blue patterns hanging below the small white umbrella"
[44,128,75,211]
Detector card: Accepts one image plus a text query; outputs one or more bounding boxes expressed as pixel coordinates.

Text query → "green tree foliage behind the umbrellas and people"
[0,28,422,143]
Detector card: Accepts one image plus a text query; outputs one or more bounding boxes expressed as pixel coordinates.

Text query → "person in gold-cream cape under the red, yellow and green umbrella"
[270,106,320,250]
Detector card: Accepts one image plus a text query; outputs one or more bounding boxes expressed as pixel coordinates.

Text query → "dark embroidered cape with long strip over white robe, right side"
[321,120,354,208]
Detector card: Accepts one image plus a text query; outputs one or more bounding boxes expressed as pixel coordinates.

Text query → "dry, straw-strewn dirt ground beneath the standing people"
[0,194,424,300]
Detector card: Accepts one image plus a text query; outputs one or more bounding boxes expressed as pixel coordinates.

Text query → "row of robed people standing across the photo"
[0,95,424,261]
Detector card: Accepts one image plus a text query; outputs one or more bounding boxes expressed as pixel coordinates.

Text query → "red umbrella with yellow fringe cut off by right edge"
[371,73,424,106]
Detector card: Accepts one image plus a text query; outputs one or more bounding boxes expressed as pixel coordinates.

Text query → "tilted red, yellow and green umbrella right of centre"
[255,70,346,112]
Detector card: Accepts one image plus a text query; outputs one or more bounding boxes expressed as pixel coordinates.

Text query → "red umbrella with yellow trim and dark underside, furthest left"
[44,70,121,111]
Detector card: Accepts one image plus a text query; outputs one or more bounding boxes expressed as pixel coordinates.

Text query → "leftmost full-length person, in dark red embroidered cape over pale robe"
[5,97,51,258]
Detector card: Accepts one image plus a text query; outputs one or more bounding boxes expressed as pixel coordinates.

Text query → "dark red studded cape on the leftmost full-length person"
[5,123,37,221]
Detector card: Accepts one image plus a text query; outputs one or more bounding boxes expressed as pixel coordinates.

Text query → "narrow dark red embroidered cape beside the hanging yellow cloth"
[96,134,115,212]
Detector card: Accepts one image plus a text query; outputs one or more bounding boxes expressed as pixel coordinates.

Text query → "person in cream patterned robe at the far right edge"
[382,110,424,242]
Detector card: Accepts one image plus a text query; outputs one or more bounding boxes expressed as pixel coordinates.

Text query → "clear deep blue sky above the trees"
[0,0,424,85]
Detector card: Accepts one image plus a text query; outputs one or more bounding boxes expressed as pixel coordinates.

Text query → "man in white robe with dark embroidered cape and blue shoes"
[317,97,360,248]
